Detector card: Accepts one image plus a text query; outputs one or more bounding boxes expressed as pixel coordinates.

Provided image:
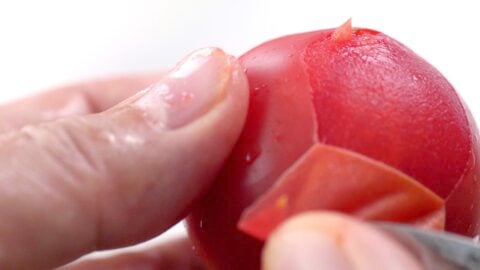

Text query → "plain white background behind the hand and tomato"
[0,0,480,260]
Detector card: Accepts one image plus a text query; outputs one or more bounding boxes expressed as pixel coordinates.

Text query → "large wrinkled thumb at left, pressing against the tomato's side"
[0,49,248,269]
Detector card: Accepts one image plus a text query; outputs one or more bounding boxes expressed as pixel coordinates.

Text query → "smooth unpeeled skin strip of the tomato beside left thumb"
[187,31,329,270]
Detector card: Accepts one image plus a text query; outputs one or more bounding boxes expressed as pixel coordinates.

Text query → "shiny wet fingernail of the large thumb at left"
[135,48,232,129]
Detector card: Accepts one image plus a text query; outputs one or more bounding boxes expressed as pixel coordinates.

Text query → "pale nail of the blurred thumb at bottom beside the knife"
[264,231,352,270]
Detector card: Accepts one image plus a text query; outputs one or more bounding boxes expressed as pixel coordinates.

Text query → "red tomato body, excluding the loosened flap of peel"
[187,23,480,270]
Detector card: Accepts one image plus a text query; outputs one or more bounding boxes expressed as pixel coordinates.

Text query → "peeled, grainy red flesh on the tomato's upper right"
[304,29,472,198]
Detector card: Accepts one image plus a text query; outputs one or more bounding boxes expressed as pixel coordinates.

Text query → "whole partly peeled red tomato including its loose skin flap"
[187,22,480,270]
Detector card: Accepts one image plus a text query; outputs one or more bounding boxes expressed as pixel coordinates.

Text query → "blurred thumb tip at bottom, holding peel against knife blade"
[262,212,422,270]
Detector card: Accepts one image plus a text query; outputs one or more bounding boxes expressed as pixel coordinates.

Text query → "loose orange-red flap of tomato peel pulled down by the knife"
[238,143,445,240]
